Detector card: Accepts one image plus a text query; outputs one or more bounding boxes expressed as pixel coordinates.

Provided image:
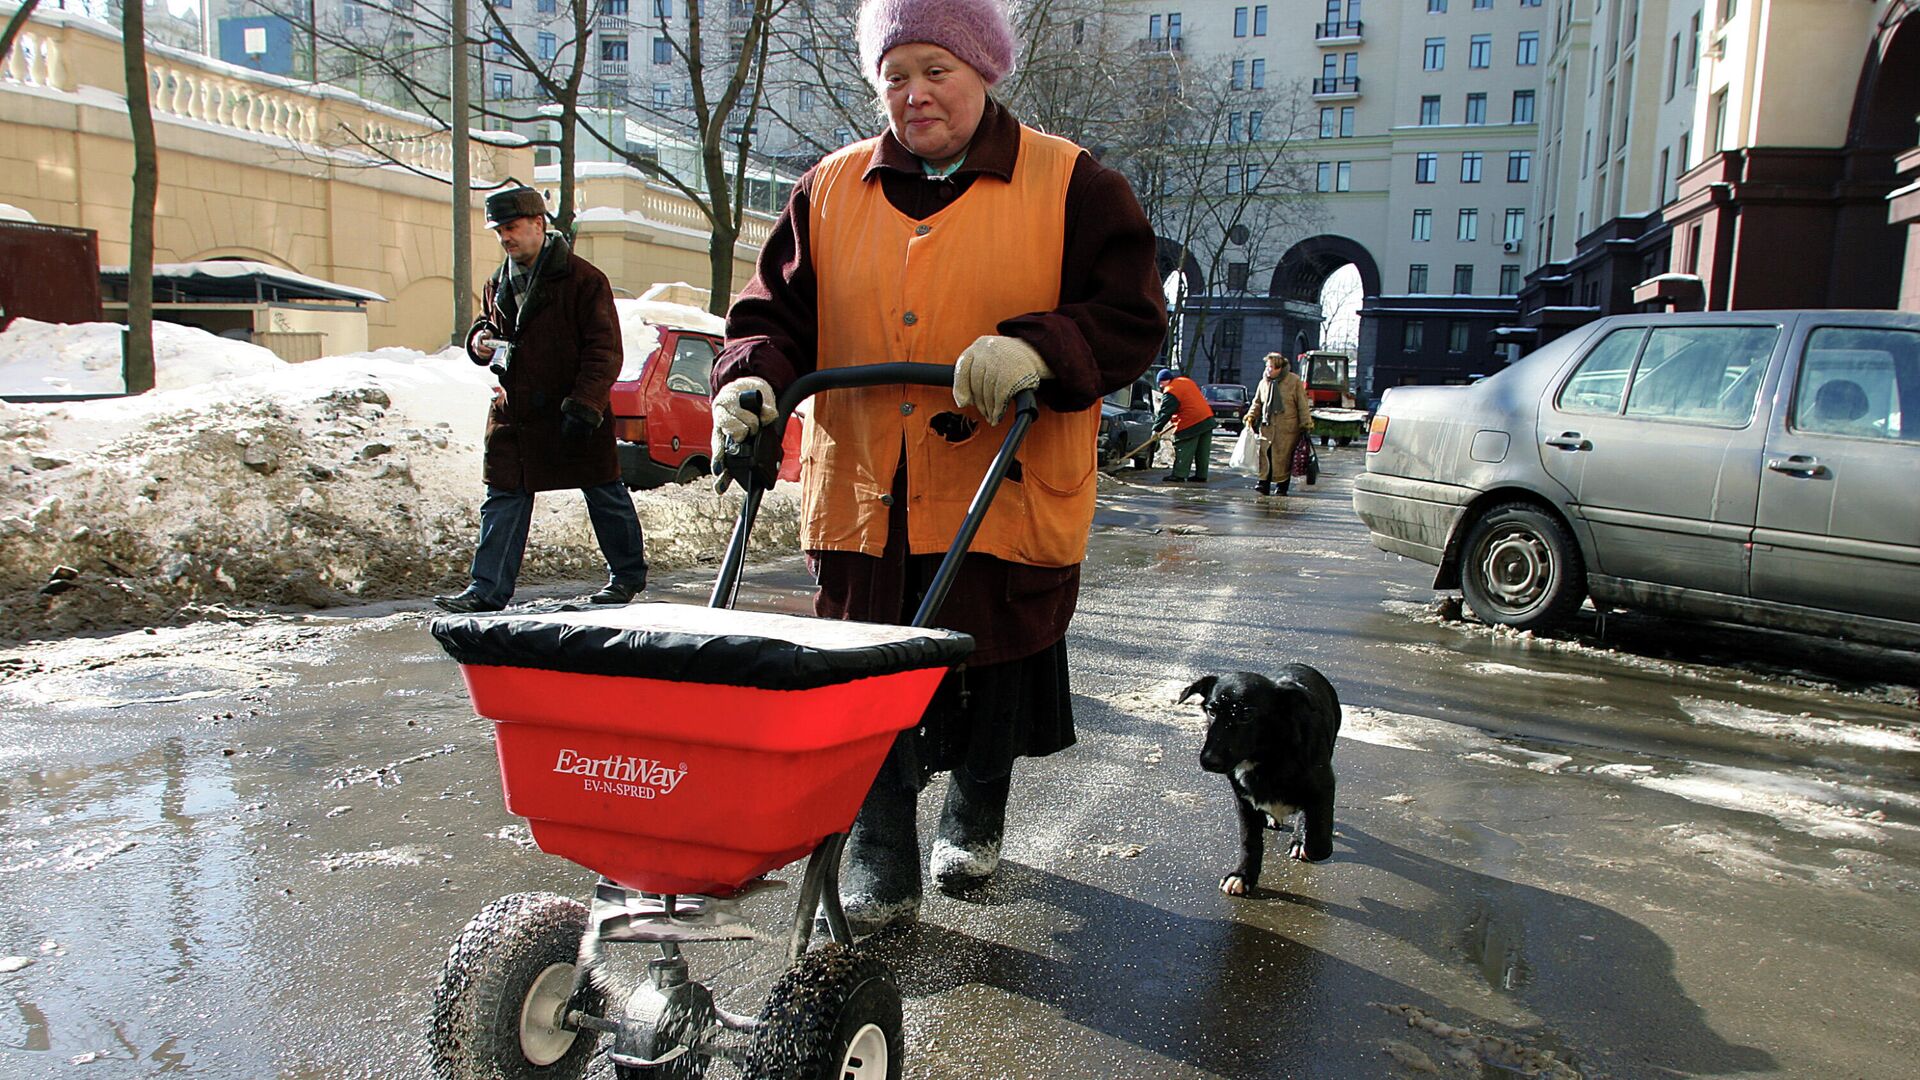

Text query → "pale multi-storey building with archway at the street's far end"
[1119,0,1548,392]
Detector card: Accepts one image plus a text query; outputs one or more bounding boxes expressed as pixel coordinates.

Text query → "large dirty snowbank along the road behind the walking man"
[0,325,797,638]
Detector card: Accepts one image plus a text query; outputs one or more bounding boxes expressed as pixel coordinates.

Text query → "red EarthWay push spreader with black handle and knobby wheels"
[428,363,1037,1080]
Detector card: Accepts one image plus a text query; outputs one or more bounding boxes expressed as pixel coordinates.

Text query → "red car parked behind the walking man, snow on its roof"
[611,284,801,490]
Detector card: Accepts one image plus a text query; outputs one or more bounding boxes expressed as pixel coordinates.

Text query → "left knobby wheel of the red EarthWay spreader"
[426,892,605,1080]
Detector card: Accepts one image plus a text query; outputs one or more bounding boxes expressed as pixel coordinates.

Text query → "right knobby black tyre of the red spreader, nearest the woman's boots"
[745,945,904,1080]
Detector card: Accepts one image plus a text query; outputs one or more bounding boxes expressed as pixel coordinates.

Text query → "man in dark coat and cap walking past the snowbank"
[434,186,647,613]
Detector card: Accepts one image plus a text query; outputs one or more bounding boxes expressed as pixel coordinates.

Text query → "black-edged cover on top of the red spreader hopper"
[430,603,973,690]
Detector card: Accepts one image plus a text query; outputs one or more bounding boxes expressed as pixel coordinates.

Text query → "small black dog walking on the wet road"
[1179,663,1340,896]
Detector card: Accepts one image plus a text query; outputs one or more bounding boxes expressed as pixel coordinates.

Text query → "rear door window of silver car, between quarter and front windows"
[1626,327,1780,427]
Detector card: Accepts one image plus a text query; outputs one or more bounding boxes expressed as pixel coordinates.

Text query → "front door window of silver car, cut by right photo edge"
[1788,327,1920,442]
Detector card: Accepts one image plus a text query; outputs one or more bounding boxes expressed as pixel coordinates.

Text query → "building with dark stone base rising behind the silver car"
[1503,0,1920,348]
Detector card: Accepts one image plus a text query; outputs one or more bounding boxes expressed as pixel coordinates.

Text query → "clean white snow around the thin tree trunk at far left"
[0,319,286,394]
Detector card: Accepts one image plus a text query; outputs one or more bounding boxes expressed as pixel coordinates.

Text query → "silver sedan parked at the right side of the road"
[1354,311,1920,646]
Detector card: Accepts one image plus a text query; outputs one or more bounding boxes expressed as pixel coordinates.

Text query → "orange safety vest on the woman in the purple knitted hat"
[801,127,1100,567]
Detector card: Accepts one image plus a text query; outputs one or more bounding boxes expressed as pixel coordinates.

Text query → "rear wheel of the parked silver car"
[1459,503,1586,630]
